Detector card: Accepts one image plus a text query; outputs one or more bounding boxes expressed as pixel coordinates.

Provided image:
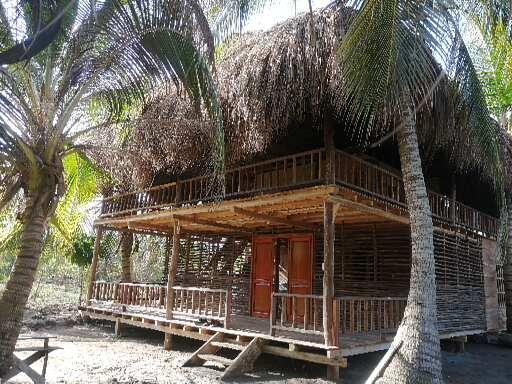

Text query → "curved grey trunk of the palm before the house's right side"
[377,97,442,384]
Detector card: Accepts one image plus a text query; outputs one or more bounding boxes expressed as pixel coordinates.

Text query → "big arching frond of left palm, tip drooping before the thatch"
[77,0,224,173]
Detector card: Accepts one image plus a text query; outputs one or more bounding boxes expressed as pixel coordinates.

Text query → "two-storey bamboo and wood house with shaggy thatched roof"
[81,3,505,378]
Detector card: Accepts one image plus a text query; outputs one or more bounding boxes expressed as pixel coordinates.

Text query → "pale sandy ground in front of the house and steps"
[10,324,512,384]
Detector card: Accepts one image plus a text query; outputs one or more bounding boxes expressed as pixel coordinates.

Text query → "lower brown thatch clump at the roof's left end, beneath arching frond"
[86,87,215,194]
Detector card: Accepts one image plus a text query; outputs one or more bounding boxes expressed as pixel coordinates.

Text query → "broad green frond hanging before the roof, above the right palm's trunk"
[338,0,449,142]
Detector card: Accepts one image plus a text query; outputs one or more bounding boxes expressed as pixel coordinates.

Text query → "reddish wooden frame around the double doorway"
[249,232,315,316]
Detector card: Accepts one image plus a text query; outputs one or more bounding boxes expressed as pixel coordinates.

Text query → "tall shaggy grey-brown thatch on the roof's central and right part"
[218,4,500,184]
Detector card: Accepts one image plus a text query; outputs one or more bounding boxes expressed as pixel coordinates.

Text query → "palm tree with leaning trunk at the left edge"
[0,0,223,377]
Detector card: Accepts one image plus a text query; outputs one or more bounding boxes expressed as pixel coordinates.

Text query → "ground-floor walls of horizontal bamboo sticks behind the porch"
[99,223,486,332]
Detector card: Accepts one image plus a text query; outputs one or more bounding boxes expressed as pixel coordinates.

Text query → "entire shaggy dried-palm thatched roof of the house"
[89,5,508,207]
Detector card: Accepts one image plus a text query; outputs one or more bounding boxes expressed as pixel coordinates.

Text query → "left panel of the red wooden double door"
[251,237,274,317]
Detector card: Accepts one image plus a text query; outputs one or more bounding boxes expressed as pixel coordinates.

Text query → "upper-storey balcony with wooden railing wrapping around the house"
[97,148,498,237]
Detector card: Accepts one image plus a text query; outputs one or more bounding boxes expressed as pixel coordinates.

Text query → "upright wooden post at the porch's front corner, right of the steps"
[323,201,339,379]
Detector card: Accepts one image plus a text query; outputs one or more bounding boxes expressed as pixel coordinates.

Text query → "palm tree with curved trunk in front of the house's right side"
[339,0,499,383]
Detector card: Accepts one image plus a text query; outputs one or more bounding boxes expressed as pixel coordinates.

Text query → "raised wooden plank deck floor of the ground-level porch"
[80,302,484,357]
